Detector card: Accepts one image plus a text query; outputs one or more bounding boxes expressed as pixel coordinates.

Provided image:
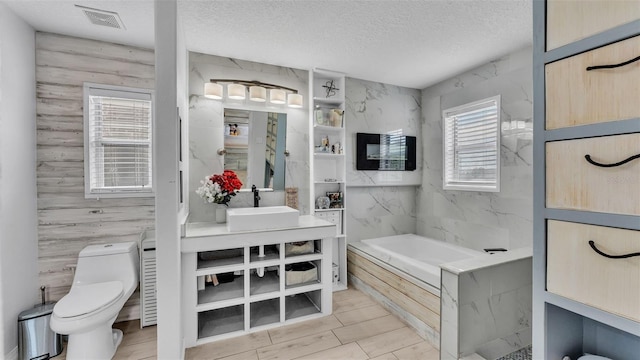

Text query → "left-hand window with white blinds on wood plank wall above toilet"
[84,83,153,198]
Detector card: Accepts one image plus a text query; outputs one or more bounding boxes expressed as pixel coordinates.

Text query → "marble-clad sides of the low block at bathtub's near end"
[440,256,532,359]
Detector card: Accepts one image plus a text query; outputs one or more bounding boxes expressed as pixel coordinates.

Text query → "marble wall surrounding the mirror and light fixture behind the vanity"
[187,52,309,222]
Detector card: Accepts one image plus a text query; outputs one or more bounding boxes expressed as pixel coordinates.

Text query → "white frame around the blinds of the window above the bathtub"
[442,94,502,192]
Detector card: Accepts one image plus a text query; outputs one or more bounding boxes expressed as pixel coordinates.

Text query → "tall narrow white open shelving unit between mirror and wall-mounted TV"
[309,69,349,290]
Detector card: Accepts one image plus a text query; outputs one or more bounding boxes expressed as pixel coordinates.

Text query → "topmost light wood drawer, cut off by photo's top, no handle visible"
[547,0,640,51]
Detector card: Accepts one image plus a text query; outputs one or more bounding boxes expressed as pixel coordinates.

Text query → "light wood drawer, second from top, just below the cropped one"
[545,36,640,129]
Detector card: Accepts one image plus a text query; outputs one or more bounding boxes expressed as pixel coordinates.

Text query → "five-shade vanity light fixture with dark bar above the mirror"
[204,79,304,108]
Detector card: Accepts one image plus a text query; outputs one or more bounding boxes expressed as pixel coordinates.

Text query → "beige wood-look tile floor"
[56,289,439,360]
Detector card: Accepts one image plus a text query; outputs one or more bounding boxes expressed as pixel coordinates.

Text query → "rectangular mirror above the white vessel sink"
[224,109,287,190]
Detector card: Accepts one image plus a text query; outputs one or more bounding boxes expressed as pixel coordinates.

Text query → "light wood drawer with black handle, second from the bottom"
[546,133,640,215]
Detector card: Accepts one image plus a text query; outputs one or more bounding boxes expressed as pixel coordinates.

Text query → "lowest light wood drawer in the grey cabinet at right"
[547,220,640,321]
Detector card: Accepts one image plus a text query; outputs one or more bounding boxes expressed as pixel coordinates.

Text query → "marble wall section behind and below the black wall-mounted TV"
[345,78,422,242]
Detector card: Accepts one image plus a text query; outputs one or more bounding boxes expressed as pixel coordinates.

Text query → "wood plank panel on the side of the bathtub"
[347,251,440,332]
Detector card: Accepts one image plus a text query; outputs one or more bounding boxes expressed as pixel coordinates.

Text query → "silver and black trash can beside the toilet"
[18,303,62,360]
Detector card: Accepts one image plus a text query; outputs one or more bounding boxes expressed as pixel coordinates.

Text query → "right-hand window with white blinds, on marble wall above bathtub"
[442,95,500,192]
